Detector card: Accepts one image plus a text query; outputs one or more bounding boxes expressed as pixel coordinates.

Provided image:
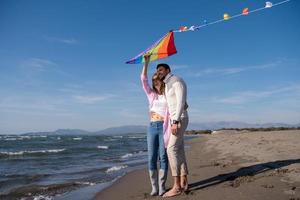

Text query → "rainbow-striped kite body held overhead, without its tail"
[126,31,177,64]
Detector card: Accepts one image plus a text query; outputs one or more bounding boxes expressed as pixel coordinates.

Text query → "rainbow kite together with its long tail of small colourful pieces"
[126,0,291,64]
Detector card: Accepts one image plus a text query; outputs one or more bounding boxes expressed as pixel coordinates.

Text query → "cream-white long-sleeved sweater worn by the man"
[164,73,188,121]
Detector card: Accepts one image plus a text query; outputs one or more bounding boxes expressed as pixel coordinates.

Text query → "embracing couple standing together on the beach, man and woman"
[141,55,188,197]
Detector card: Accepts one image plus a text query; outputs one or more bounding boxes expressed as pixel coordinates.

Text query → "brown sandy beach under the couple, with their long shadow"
[95,130,300,200]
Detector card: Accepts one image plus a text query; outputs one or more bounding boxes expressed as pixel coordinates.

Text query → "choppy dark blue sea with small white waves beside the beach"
[0,134,147,200]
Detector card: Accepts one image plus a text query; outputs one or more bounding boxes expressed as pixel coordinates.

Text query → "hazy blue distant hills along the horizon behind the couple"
[22,121,300,135]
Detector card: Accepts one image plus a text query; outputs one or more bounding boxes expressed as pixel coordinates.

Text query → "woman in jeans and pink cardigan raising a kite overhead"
[141,55,170,196]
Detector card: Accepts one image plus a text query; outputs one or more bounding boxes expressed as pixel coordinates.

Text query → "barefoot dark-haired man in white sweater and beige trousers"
[156,63,188,197]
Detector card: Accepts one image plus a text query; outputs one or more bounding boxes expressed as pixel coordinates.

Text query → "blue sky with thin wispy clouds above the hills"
[0,0,300,133]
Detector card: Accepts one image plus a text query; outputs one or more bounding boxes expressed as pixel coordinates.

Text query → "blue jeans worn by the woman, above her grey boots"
[147,121,168,170]
